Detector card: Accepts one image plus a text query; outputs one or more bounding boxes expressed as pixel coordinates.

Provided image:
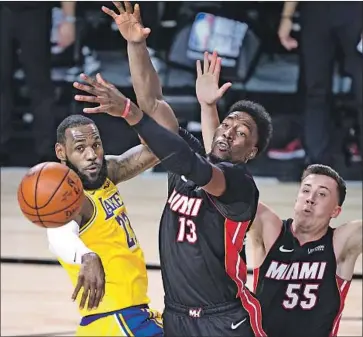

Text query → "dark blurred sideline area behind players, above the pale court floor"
[0,1,363,181]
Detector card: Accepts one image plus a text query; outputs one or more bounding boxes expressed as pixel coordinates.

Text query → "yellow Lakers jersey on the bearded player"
[59,179,149,316]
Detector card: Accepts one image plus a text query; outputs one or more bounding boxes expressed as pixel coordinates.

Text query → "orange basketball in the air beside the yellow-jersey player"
[18,162,84,228]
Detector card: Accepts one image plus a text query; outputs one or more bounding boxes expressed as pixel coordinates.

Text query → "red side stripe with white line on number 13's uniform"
[224,219,267,337]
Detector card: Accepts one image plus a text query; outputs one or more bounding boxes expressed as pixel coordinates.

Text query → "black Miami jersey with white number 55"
[254,219,350,337]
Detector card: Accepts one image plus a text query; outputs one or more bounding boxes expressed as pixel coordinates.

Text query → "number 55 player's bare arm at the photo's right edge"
[333,219,363,280]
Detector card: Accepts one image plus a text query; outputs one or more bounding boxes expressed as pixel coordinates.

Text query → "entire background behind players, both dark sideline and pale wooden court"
[0,1,363,336]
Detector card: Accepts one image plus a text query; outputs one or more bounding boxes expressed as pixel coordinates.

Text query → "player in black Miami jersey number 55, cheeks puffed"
[250,165,362,337]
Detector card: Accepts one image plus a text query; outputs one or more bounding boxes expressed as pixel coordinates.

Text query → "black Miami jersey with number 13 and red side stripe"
[159,131,262,335]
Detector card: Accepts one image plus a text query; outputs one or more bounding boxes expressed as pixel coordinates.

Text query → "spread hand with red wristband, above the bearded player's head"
[73,74,127,117]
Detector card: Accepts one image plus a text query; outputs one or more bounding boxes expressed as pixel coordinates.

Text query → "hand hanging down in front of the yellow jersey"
[72,253,105,310]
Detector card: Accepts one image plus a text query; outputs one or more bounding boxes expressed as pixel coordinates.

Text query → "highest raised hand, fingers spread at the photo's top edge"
[102,1,151,43]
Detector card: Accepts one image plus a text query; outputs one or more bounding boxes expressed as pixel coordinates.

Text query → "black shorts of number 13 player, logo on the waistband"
[163,301,255,337]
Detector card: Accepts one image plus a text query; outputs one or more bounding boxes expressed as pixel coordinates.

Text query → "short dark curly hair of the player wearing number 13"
[228,100,272,153]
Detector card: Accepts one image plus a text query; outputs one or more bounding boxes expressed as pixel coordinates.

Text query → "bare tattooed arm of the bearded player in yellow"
[106,145,159,184]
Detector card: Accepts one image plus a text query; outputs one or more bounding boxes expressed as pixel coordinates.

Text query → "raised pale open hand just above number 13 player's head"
[195,52,232,105]
